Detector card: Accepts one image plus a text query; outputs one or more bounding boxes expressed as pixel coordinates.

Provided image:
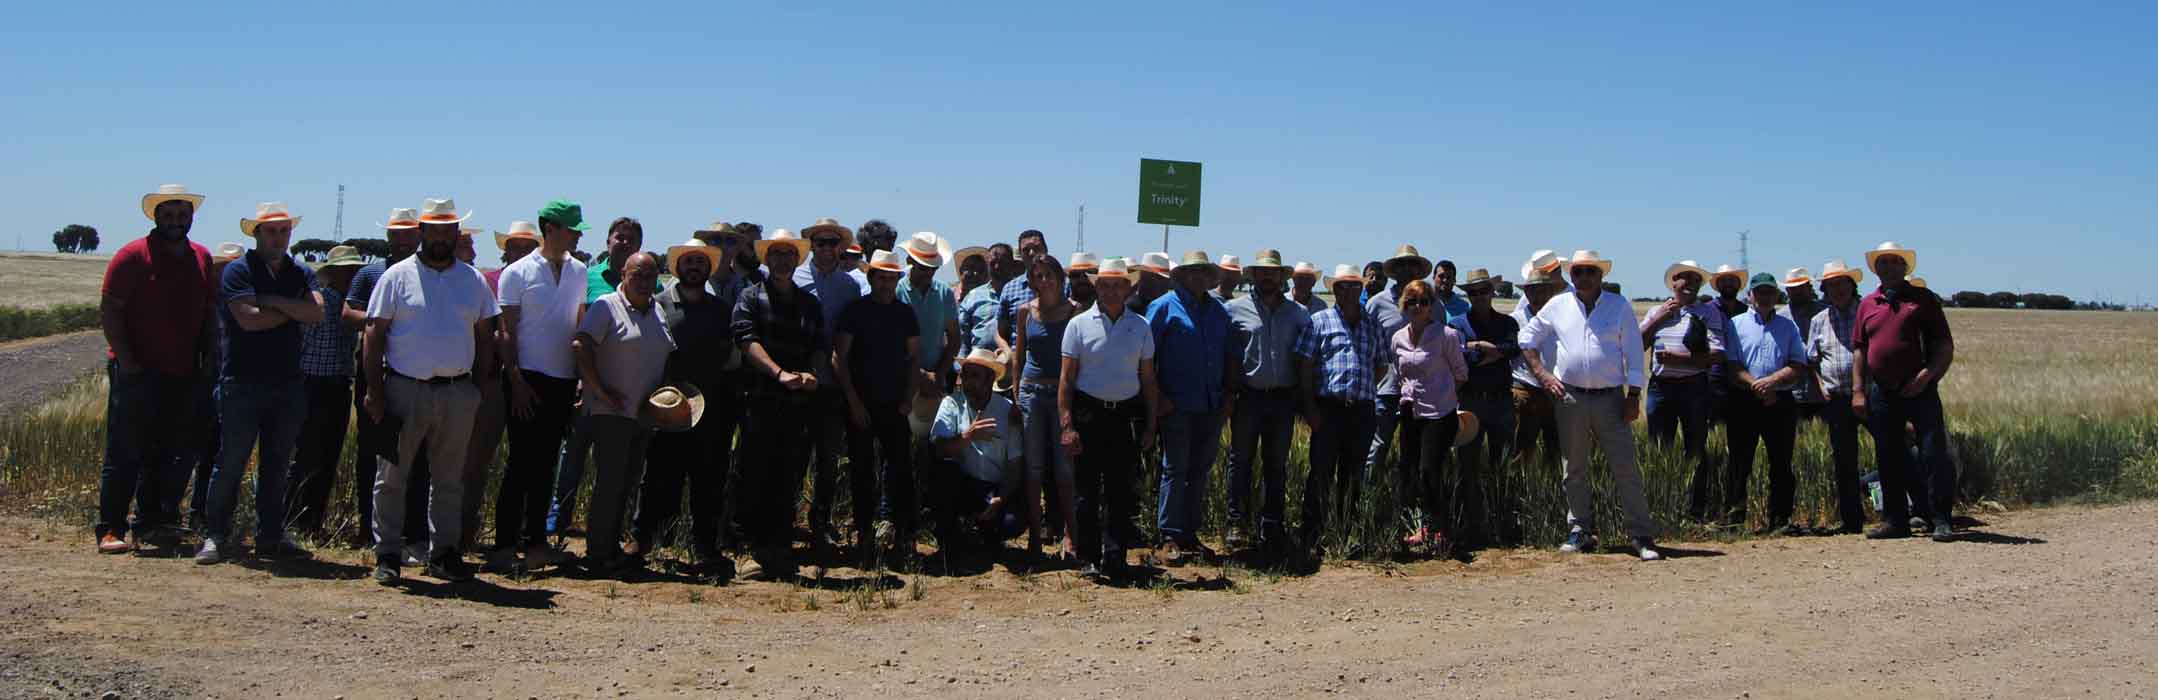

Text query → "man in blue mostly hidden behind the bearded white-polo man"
[339,210,427,553]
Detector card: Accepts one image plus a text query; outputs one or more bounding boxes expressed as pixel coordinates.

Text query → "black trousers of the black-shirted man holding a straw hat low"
[630,393,742,557]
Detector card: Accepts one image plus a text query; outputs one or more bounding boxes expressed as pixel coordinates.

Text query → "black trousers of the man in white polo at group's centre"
[1068,389,1146,566]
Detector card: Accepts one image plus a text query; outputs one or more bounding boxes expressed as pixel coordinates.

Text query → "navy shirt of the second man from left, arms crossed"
[218,251,315,380]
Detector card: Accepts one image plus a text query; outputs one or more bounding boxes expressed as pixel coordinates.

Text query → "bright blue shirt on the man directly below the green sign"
[1146,287,1230,413]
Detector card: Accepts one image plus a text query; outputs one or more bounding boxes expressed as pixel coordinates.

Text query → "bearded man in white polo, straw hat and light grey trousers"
[360,199,498,585]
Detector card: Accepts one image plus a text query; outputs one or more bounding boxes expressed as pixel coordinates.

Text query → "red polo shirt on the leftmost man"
[104,235,216,376]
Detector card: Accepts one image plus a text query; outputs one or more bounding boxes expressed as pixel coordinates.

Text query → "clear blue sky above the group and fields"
[0,2,2158,302]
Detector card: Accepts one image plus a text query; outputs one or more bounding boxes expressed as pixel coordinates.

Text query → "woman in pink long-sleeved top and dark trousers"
[1394,281,1483,555]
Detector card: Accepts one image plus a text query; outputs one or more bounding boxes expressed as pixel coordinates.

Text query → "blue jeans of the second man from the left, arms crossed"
[203,378,306,547]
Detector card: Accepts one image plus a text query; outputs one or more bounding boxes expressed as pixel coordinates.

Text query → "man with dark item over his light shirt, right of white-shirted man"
[1640,259,1729,523]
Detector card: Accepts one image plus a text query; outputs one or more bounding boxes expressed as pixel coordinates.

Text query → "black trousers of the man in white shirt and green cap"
[496,369,576,547]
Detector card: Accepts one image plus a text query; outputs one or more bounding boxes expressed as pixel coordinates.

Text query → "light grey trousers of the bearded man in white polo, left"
[375,376,479,557]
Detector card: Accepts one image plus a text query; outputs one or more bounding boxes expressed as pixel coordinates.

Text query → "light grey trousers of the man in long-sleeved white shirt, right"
[1554,389,1655,538]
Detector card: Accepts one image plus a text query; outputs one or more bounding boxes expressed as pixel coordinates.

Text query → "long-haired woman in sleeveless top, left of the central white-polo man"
[1010,255,1079,560]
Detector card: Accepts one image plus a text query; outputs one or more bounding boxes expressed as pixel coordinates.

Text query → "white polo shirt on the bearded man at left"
[367,255,501,378]
